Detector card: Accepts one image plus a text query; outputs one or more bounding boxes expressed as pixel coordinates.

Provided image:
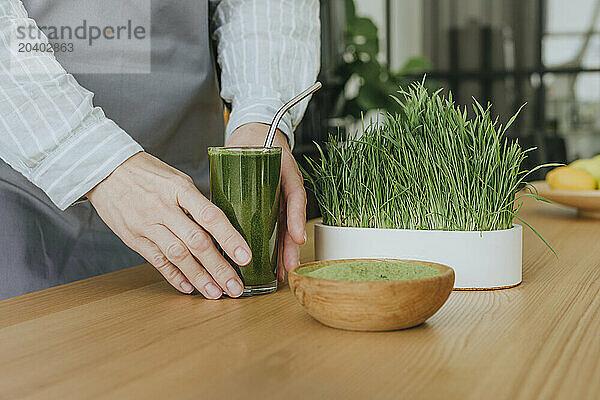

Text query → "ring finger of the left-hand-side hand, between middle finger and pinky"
[147,225,223,299]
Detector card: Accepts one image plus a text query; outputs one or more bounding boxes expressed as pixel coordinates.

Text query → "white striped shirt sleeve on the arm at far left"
[0,0,142,210]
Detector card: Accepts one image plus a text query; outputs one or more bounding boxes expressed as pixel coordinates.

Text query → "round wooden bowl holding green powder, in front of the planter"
[289,259,454,331]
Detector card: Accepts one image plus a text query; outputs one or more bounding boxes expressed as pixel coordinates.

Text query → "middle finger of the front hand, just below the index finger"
[164,210,243,297]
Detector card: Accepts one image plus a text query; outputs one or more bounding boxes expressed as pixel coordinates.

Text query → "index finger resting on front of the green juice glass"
[178,187,252,265]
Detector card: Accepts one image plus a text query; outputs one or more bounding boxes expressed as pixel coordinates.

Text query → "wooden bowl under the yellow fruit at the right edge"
[532,181,600,218]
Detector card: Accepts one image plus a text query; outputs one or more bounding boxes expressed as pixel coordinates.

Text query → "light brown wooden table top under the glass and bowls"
[0,204,600,399]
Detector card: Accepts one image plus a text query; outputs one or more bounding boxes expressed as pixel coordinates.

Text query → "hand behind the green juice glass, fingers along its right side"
[226,123,306,281]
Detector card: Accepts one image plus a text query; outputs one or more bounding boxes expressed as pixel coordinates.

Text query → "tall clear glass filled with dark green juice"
[208,147,281,296]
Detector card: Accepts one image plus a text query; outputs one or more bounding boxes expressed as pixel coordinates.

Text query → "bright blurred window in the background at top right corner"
[543,0,600,161]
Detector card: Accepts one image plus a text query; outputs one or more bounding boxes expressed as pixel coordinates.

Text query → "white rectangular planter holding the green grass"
[315,223,523,289]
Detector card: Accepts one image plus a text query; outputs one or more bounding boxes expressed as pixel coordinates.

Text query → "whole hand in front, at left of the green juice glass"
[87,153,252,299]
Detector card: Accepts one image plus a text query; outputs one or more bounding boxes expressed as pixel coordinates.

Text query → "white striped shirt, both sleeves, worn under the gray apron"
[0,0,320,210]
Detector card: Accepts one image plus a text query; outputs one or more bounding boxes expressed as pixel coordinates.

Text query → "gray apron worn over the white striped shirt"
[0,0,223,299]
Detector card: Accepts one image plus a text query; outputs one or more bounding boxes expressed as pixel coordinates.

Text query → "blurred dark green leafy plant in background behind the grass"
[334,0,439,119]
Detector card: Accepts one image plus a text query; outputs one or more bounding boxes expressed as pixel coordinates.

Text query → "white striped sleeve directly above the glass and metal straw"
[212,0,321,146]
